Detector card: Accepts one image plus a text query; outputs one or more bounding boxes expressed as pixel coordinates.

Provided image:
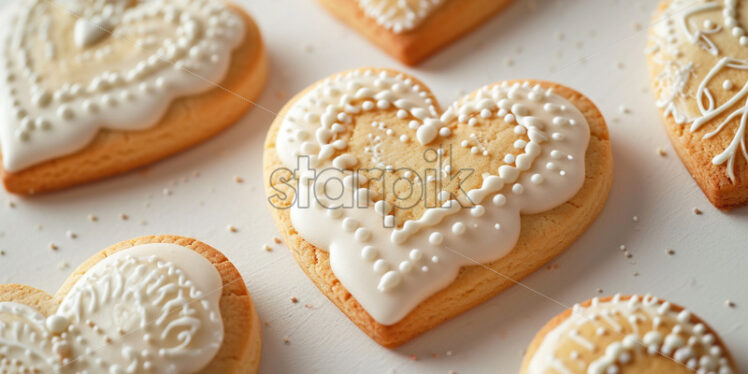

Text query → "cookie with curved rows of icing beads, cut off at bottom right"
[520,295,738,374]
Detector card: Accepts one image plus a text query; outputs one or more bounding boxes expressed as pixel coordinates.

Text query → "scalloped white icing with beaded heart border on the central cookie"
[276,70,590,325]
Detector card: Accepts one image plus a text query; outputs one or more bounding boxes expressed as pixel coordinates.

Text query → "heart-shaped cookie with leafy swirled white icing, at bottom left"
[0,236,261,373]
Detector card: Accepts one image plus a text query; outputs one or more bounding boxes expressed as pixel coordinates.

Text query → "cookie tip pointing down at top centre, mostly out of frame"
[318,0,512,65]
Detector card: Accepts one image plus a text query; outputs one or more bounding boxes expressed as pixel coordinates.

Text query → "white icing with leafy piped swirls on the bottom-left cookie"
[0,243,223,373]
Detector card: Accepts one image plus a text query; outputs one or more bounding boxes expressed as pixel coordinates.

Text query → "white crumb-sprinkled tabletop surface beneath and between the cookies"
[0,0,748,373]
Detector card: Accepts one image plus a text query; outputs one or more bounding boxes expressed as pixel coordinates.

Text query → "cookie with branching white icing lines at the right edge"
[648,0,748,209]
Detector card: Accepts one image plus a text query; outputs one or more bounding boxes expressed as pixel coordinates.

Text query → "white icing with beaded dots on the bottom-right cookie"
[527,295,733,374]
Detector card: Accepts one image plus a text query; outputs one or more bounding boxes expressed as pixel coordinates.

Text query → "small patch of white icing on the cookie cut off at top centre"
[357,0,445,34]
